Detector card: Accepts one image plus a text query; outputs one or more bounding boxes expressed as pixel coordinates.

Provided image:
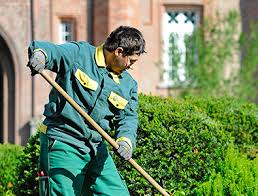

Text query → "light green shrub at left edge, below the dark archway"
[0,144,22,195]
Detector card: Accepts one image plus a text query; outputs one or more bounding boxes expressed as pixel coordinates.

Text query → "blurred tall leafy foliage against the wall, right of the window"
[166,11,258,102]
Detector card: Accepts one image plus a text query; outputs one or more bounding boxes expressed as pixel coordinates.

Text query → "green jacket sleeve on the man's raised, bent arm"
[28,41,80,74]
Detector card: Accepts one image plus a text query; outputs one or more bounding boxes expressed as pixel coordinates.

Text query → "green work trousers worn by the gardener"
[39,133,130,196]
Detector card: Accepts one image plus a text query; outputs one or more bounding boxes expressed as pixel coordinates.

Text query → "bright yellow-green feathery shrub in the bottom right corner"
[194,145,258,196]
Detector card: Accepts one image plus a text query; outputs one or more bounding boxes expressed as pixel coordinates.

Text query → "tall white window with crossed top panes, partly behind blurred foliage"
[162,10,200,85]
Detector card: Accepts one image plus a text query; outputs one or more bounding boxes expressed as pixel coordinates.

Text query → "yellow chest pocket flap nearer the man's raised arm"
[75,69,98,91]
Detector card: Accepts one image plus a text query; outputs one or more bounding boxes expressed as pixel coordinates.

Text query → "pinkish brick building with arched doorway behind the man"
[0,0,258,144]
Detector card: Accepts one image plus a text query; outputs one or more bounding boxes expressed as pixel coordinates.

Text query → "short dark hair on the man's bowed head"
[103,26,145,56]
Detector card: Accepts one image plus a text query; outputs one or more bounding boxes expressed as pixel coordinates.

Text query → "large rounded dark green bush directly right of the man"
[114,95,230,195]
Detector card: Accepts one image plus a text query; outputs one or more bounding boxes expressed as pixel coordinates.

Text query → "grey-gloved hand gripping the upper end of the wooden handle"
[27,49,46,76]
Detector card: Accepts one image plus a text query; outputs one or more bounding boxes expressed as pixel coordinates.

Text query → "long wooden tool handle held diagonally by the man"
[40,70,169,196]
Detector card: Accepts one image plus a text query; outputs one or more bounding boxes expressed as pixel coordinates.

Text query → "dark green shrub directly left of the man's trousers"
[15,133,40,196]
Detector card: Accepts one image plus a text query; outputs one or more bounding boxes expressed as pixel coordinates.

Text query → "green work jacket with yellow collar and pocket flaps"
[28,41,138,153]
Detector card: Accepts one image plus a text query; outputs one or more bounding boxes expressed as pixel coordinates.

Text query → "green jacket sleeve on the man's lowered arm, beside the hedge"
[114,81,138,148]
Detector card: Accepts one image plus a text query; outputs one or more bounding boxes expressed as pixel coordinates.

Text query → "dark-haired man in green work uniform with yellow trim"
[28,26,145,196]
